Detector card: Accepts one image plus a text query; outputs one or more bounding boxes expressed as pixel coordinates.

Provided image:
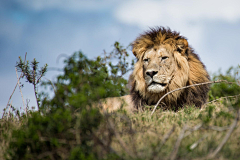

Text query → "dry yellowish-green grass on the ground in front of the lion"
[108,103,240,159]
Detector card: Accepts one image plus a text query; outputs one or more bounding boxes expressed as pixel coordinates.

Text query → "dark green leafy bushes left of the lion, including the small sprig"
[5,42,133,159]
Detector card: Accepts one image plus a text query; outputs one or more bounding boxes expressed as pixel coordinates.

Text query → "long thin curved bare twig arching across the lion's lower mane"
[151,80,235,116]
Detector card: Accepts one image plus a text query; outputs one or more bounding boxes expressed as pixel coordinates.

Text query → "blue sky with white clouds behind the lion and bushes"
[0,0,240,114]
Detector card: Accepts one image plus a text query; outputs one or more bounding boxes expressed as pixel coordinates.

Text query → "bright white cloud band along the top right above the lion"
[115,0,240,28]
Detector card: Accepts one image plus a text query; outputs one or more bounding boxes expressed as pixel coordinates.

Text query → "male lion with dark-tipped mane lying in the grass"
[104,27,209,110]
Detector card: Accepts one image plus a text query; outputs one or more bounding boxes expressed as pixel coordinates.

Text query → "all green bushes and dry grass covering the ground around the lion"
[0,42,240,160]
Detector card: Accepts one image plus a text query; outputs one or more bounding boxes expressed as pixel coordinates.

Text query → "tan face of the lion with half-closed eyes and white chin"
[143,46,176,93]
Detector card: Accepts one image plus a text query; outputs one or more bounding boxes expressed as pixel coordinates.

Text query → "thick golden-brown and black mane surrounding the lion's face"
[130,27,209,110]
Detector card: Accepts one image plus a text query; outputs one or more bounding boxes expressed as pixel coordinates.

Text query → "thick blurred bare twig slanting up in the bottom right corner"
[207,109,240,159]
